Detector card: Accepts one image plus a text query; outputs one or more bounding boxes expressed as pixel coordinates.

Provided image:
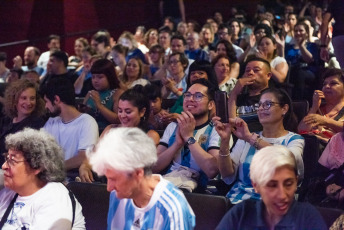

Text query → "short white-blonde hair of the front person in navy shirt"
[250,145,297,186]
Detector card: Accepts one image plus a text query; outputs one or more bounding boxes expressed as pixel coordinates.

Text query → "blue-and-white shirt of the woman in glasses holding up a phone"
[223,132,305,204]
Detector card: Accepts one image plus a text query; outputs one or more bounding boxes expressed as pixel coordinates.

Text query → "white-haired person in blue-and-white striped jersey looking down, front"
[88,127,195,229]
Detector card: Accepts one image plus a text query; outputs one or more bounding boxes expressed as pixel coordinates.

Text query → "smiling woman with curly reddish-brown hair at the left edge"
[0,79,45,164]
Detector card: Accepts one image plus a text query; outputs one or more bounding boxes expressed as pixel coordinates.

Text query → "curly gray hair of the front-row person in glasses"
[5,128,65,182]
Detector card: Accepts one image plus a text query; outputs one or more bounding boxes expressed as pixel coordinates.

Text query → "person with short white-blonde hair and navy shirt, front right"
[216,146,328,230]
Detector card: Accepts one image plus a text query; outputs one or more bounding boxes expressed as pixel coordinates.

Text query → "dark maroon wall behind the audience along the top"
[0,0,258,60]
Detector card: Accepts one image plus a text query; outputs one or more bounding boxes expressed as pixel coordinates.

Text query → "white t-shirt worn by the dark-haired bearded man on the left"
[44,113,99,160]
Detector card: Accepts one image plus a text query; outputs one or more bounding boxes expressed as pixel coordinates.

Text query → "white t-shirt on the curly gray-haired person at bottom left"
[0,182,86,230]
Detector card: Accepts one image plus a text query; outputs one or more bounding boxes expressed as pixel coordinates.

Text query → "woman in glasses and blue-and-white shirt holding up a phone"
[213,88,304,204]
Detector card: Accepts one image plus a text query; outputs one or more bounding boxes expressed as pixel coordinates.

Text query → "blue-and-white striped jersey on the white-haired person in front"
[107,175,195,230]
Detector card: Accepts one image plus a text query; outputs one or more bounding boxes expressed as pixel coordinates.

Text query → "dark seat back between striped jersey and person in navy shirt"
[184,193,232,230]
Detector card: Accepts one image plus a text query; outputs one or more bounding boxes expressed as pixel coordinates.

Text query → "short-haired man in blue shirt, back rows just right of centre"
[185,32,209,61]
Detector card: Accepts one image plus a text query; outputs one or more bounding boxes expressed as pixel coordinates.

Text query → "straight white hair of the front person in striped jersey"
[87,127,158,175]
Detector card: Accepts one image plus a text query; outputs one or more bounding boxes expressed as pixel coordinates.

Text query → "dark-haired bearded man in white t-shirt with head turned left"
[43,78,99,180]
